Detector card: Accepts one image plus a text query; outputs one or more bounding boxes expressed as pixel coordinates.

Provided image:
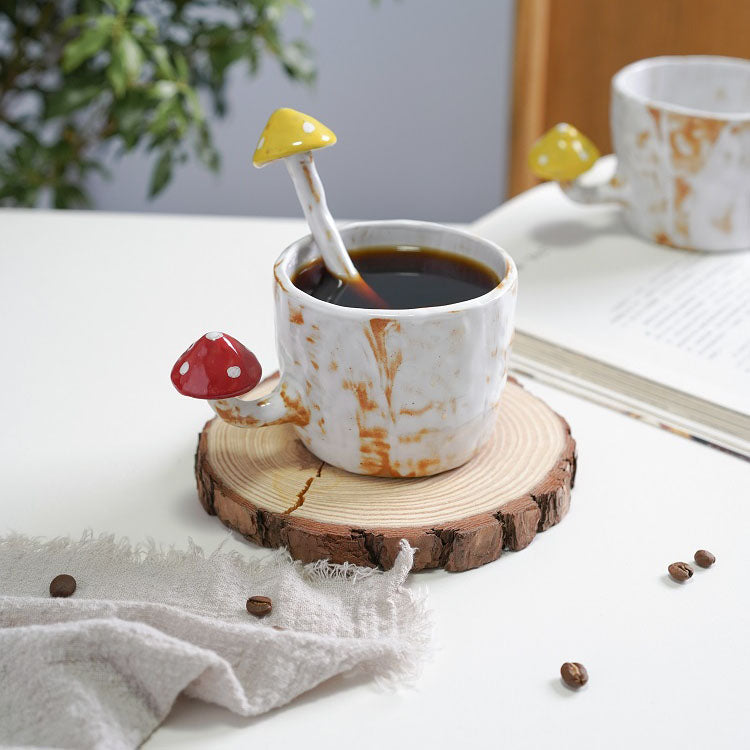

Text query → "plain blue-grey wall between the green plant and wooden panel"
[92,0,514,221]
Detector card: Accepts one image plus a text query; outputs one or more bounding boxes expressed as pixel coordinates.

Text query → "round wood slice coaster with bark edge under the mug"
[195,381,576,571]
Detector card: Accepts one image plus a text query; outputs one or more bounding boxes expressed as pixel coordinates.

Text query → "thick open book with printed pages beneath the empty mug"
[472,184,750,458]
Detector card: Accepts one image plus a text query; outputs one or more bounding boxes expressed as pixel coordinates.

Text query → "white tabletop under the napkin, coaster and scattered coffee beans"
[0,210,750,750]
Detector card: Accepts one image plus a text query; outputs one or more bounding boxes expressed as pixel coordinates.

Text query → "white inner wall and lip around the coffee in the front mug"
[276,221,516,315]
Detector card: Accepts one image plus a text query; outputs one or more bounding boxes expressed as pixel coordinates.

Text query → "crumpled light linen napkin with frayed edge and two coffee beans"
[0,533,430,748]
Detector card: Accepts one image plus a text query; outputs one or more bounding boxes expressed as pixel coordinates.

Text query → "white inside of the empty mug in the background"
[612,55,750,119]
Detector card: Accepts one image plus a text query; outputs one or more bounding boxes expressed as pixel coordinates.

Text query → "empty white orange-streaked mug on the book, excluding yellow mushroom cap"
[560,56,750,251]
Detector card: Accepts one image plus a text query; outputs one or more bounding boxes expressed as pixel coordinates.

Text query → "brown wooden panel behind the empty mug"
[508,0,750,195]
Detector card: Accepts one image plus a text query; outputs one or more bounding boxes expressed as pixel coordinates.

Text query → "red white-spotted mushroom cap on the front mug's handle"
[172,331,261,399]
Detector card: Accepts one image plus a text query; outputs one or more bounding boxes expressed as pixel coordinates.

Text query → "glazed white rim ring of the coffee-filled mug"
[273,219,518,319]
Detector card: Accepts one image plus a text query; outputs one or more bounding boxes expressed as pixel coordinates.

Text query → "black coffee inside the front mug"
[292,245,500,310]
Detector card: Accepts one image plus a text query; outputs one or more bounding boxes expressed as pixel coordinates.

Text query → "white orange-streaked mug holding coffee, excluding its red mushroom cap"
[209,221,517,477]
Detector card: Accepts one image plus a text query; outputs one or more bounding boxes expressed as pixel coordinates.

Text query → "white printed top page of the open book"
[472,185,750,413]
